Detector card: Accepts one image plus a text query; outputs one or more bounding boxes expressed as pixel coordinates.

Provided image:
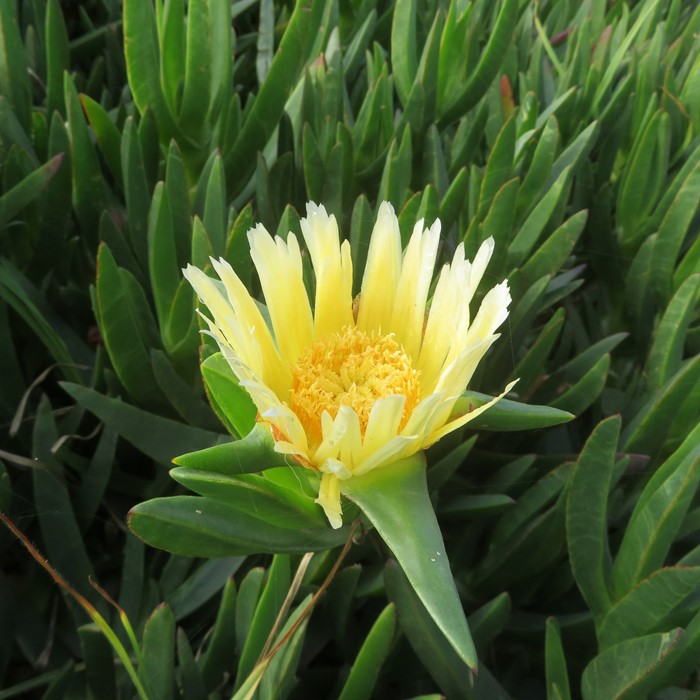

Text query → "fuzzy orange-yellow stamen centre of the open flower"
[289,326,420,444]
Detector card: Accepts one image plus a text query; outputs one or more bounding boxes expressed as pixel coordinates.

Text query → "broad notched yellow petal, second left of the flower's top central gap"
[248,225,313,367]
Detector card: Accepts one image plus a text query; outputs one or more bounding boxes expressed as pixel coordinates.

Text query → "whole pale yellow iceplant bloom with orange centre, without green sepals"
[184,202,512,528]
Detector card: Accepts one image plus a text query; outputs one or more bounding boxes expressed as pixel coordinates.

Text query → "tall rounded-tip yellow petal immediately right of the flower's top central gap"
[357,202,401,333]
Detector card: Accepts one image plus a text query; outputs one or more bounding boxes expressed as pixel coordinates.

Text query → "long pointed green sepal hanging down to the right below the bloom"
[341,452,477,670]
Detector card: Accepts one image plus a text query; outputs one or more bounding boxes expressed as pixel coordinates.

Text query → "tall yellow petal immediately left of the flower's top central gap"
[301,202,353,338]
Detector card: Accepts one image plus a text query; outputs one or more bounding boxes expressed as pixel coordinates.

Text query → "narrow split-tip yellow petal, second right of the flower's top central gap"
[389,219,440,358]
